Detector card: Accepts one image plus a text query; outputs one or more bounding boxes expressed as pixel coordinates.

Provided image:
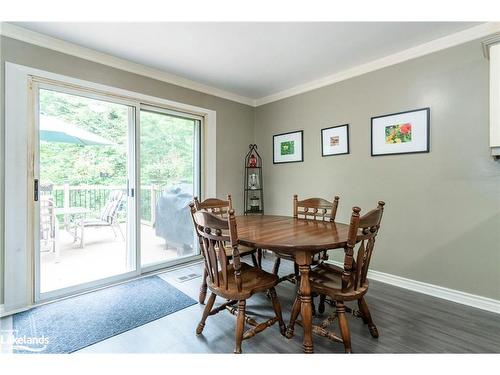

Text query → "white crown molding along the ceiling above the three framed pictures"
[255,22,500,107]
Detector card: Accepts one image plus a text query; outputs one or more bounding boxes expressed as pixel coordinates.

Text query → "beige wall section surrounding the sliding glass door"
[0,37,254,303]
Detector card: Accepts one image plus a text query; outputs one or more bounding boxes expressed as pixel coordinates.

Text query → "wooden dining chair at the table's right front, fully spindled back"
[287,201,385,353]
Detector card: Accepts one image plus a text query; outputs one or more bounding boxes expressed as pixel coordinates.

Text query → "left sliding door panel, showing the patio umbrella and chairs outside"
[34,84,137,300]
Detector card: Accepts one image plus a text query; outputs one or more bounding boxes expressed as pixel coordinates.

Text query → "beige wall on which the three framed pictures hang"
[255,42,500,299]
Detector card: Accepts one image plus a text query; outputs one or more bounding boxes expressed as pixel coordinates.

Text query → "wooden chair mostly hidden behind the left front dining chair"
[193,194,262,304]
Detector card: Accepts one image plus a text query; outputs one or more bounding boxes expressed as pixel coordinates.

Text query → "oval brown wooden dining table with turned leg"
[236,215,349,353]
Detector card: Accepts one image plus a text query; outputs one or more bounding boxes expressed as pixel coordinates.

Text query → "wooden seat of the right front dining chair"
[309,263,368,301]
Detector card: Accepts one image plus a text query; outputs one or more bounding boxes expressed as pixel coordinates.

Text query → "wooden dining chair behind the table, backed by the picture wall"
[273,194,340,283]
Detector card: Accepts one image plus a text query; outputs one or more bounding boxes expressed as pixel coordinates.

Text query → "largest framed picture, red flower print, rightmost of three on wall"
[371,108,431,156]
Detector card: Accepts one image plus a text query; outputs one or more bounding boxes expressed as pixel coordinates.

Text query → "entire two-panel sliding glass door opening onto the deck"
[32,82,203,301]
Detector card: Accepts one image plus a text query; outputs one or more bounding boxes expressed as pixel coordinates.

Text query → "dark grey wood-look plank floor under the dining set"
[75,255,500,353]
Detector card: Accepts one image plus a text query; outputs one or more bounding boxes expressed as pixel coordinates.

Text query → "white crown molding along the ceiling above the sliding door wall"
[0,22,255,106]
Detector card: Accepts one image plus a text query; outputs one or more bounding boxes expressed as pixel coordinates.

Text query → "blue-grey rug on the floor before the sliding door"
[13,276,196,354]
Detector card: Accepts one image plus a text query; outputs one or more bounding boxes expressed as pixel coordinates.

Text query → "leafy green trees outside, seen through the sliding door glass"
[39,89,196,186]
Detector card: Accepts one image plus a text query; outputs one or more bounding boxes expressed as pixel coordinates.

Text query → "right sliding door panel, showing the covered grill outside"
[139,106,202,269]
